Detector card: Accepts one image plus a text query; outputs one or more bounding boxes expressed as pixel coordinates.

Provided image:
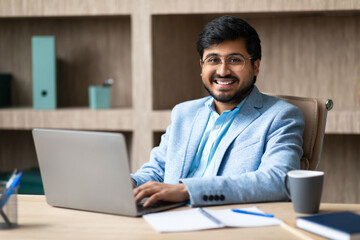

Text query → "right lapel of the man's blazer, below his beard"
[214,87,262,174]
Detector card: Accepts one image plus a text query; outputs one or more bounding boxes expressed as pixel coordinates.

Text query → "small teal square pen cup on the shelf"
[89,78,114,109]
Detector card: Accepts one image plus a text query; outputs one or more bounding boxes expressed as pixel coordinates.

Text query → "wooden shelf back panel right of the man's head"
[252,15,360,110]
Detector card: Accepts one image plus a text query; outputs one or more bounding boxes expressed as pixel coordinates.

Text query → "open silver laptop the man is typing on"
[33,129,184,216]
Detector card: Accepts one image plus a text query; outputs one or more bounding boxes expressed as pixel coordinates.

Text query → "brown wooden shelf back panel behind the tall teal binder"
[0,17,132,107]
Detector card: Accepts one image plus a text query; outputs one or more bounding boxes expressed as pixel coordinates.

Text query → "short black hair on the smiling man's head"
[196,16,261,64]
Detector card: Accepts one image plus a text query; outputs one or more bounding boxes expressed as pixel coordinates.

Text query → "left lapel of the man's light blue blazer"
[180,104,210,178]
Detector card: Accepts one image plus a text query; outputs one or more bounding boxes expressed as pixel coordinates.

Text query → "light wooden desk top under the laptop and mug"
[0,195,360,240]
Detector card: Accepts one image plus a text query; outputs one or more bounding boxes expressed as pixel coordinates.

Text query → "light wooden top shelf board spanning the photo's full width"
[0,0,360,17]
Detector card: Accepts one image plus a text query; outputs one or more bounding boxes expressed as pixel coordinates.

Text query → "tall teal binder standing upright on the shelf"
[31,36,57,109]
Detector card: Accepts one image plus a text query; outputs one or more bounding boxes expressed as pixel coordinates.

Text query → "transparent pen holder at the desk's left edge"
[0,182,18,230]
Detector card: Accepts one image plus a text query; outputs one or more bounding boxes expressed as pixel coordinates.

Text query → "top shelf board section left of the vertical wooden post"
[0,0,133,17]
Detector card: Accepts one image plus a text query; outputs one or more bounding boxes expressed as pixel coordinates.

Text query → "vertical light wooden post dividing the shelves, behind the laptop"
[131,0,153,172]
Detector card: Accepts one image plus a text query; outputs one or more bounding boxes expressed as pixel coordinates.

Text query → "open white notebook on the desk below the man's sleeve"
[143,207,282,232]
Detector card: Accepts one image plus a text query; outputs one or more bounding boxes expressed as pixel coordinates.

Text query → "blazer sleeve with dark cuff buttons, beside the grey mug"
[180,106,304,206]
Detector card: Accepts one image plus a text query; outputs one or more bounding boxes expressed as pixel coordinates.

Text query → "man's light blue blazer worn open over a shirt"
[131,87,304,206]
